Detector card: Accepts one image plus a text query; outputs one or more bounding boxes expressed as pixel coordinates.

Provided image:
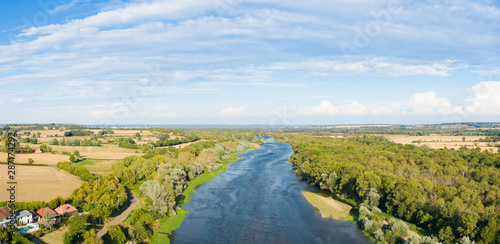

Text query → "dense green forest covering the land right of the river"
[278,134,500,243]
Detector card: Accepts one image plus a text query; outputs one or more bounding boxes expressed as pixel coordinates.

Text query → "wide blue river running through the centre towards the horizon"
[171,139,372,244]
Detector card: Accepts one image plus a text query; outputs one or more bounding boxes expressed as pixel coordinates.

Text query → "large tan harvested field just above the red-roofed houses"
[0,164,83,202]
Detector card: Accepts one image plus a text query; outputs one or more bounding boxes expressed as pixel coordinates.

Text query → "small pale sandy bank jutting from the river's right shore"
[302,191,352,220]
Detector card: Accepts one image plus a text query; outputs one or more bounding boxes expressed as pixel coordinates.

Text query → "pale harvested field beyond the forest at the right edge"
[384,135,498,152]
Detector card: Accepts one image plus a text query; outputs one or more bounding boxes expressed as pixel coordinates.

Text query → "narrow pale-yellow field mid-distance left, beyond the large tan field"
[51,144,142,159]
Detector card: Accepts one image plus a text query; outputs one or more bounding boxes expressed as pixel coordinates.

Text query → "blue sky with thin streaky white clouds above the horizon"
[0,0,500,125]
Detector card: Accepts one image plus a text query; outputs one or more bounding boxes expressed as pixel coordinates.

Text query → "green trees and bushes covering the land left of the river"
[0,126,262,244]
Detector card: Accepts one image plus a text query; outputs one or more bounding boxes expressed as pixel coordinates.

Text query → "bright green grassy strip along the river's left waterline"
[151,146,260,244]
